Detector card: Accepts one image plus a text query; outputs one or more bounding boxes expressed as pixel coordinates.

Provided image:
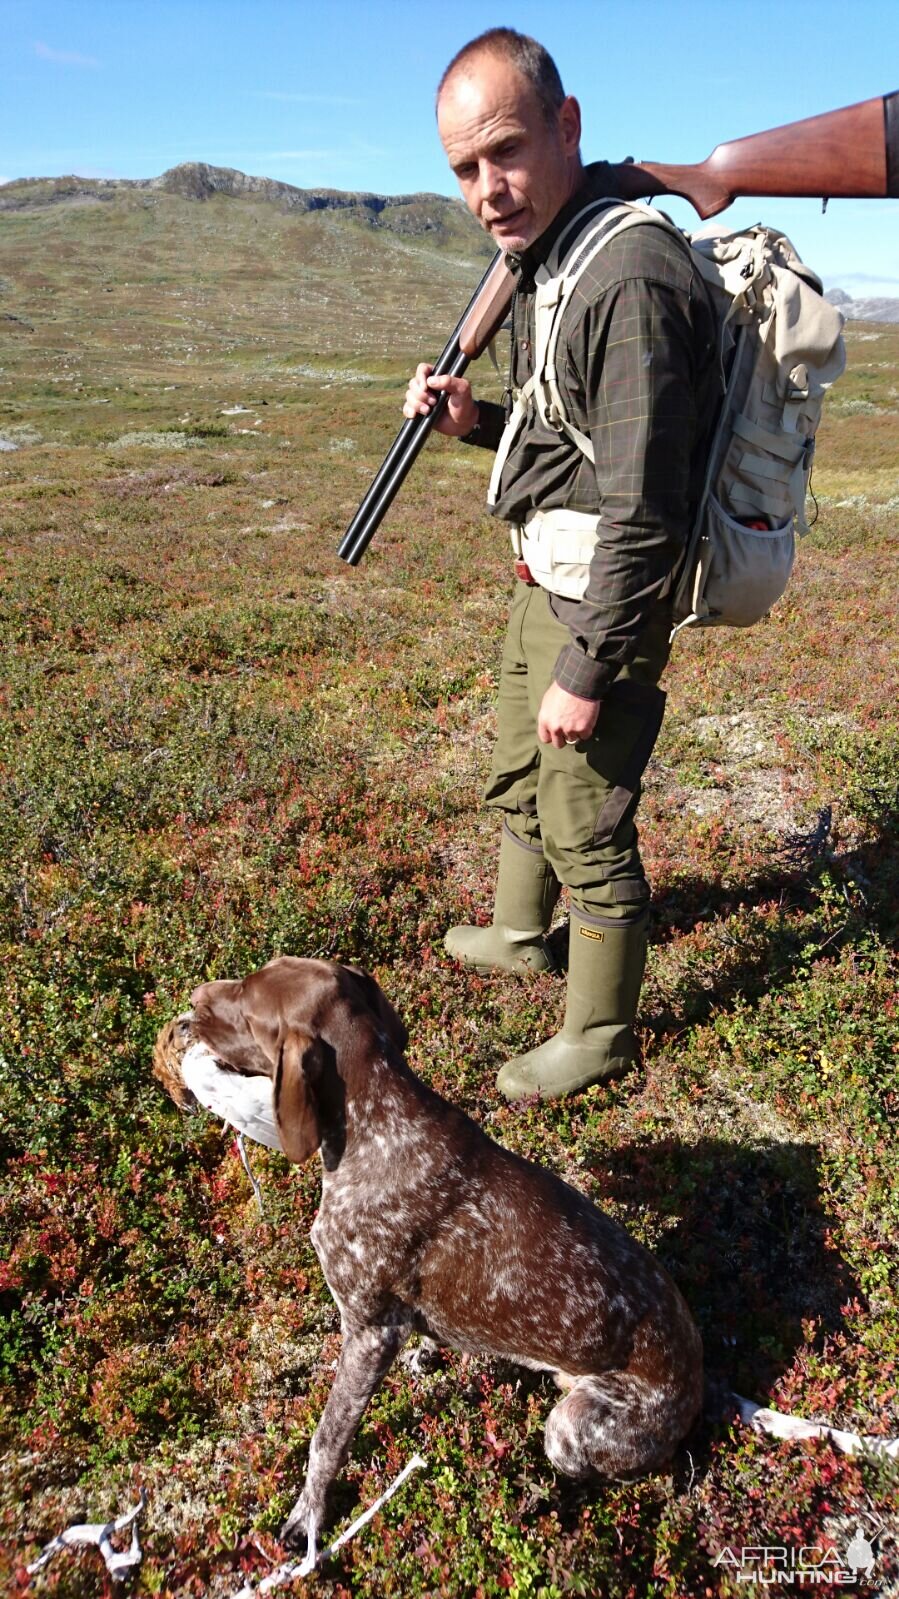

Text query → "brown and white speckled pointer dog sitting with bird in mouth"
[154,956,702,1570]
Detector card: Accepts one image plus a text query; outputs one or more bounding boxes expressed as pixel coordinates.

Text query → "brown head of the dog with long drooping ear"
[187,956,406,1162]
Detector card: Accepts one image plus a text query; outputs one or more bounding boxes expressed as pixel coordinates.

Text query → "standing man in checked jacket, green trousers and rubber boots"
[403,29,717,1099]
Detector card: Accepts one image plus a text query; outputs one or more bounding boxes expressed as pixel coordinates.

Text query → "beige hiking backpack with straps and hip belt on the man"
[488,200,846,636]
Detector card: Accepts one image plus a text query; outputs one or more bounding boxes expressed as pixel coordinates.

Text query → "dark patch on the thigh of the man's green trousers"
[587,678,665,844]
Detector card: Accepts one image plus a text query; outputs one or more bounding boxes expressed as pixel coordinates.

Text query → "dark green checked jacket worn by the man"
[469,161,720,699]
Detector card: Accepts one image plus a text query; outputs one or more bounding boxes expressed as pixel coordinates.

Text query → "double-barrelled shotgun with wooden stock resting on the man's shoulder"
[338,91,899,566]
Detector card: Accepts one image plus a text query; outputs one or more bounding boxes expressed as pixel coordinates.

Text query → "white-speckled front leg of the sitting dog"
[280,1326,411,1575]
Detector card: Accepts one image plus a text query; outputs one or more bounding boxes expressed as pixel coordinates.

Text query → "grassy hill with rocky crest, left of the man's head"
[0,161,493,399]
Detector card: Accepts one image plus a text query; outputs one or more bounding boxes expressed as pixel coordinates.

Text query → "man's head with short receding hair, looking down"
[437,27,581,254]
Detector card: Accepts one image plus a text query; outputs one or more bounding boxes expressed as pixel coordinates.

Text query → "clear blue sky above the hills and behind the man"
[0,0,899,297]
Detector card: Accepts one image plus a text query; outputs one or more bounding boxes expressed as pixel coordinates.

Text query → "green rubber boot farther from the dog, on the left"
[443,827,561,974]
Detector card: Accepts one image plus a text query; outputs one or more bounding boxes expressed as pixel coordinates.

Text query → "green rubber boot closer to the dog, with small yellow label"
[496,910,649,1100]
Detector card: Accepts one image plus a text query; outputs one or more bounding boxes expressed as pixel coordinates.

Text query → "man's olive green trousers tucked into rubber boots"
[485,580,672,926]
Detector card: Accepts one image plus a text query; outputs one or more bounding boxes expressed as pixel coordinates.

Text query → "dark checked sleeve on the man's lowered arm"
[553,277,697,699]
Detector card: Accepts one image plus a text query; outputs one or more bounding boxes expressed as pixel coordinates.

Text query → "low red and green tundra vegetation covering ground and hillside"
[0,184,899,1599]
